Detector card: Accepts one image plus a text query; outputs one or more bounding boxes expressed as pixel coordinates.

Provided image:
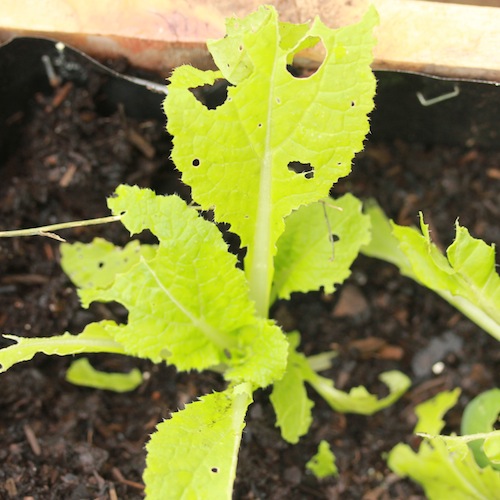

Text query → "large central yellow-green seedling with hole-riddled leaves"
[0,6,409,499]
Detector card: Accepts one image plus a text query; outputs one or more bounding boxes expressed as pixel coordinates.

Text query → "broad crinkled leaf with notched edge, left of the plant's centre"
[72,186,287,385]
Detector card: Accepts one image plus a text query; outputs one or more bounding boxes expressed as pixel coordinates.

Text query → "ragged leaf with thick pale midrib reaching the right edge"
[362,206,500,340]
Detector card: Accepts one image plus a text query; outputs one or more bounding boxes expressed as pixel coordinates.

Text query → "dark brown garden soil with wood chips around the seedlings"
[0,52,500,500]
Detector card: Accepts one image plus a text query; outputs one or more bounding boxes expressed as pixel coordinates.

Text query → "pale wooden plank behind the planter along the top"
[0,0,500,82]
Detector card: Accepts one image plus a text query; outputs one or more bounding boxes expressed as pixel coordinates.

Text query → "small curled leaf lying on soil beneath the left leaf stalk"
[66,358,142,392]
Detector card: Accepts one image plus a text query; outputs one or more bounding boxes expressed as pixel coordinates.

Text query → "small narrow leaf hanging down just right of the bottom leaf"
[271,333,314,443]
